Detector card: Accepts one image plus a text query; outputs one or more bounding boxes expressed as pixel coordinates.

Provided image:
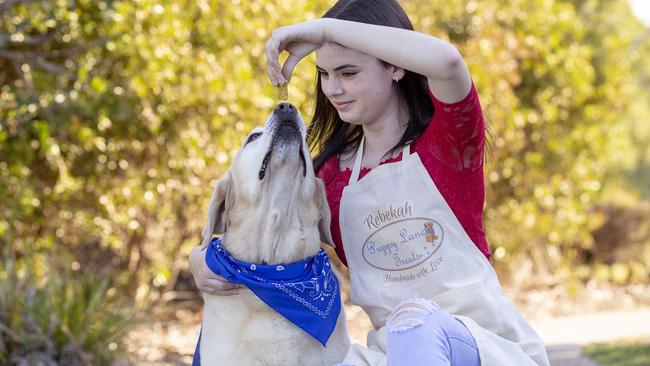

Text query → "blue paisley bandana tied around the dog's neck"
[205,238,341,346]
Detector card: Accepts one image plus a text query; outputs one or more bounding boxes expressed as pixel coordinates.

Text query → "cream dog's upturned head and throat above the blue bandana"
[203,103,332,263]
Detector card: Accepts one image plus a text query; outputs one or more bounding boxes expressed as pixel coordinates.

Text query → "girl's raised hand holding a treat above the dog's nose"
[264,19,326,86]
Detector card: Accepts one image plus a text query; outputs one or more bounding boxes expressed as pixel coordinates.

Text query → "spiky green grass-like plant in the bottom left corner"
[0,249,135,365]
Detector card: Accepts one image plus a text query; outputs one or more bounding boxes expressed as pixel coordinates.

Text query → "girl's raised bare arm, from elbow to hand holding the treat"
[266,18,471,103]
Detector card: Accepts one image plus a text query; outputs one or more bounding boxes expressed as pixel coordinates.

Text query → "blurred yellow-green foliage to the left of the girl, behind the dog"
[0,1,330,300]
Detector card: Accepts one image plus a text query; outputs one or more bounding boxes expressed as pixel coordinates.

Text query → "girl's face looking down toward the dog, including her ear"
[316,43,403,125]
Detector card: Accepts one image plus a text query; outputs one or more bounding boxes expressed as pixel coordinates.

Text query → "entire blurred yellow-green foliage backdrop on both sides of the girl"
[0,0,650,314]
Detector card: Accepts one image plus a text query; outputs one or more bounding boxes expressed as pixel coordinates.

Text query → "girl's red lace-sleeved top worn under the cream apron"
[317,84,491,265]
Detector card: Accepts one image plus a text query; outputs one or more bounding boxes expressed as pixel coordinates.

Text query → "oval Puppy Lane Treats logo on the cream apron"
[362,217,444,271]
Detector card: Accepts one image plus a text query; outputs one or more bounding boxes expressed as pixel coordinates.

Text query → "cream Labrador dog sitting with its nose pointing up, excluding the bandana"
[199,103,350,366]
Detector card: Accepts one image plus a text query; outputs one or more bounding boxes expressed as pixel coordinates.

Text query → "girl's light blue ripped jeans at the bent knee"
[339,299,481,366]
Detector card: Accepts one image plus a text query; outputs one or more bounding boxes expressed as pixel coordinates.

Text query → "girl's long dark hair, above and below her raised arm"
[307,0,434,170]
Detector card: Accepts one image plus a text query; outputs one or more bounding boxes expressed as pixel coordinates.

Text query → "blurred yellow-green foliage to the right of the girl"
[398,0,650,282]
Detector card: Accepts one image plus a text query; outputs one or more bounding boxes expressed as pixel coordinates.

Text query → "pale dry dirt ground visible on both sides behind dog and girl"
[115,283,650,365]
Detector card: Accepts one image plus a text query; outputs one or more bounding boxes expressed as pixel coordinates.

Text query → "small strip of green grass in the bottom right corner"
[584,342,650,366]
